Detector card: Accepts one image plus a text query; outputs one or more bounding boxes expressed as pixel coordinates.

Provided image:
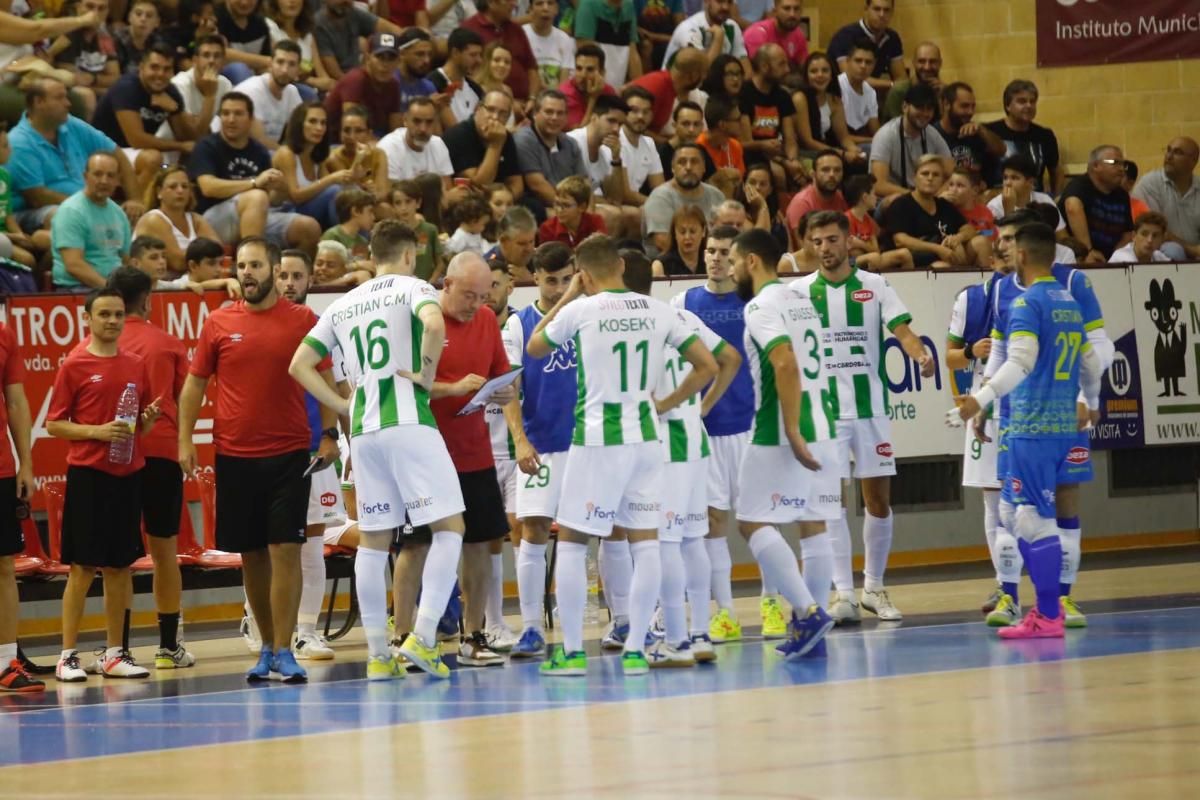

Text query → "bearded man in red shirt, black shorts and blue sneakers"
[179,236,337,682]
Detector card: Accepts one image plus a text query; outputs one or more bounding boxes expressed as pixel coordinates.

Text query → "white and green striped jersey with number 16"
[305,275,439,437]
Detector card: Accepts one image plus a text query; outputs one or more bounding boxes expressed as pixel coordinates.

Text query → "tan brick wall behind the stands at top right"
[805,0,1200,172]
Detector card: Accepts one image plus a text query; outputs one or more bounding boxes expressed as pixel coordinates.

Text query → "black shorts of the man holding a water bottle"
[62,467,145,569]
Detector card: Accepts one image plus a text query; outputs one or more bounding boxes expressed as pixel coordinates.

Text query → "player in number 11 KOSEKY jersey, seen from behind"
[526,235,716,675]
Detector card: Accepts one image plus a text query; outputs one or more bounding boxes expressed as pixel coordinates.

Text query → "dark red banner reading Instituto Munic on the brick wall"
[1037,0,1200,67]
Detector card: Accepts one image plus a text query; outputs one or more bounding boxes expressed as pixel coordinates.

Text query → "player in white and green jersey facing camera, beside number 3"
[793,211,935,622]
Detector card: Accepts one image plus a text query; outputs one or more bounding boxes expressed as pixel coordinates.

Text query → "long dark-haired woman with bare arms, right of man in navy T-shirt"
[271,102,358,230]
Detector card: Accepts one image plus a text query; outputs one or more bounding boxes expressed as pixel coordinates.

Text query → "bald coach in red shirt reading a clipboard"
[392,253,516,667]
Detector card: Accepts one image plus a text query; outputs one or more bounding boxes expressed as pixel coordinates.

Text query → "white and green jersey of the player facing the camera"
[792,267,912,420]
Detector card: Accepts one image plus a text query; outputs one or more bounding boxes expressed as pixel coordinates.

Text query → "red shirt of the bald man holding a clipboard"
[430,306,509,473]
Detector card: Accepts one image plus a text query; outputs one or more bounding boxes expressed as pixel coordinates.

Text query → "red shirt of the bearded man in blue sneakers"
[190,297,330,458]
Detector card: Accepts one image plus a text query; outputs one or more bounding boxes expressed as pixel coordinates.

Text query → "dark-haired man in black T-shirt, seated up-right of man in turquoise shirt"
[94,42,200,192]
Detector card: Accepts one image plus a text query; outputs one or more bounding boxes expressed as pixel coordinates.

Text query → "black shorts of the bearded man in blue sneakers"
[216,450,311,553]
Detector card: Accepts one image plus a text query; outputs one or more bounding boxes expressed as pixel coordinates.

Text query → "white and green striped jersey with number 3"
[745,281,835,445]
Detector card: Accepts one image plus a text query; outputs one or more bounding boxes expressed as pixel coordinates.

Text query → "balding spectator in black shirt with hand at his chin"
[443,91,524,198]
